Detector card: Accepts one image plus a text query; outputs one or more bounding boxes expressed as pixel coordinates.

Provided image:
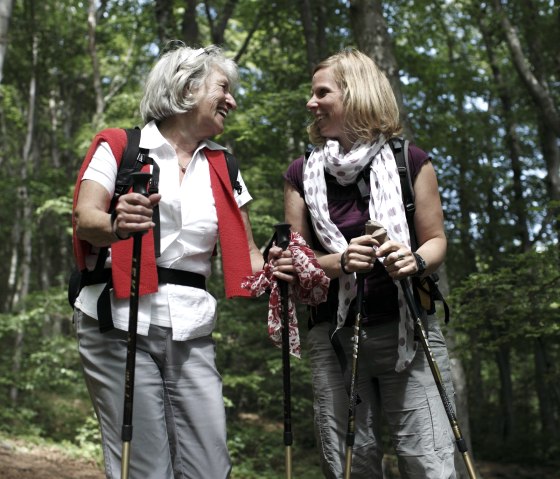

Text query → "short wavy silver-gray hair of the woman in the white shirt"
[140,41,238,123]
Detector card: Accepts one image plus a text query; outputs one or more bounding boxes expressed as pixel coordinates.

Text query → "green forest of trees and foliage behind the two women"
[0,0,560,479]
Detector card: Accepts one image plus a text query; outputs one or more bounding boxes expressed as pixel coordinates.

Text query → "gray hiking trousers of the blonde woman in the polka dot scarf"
[308,317,455,479]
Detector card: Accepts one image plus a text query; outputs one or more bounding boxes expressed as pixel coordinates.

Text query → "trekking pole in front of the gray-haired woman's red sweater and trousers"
[121,173,152,479]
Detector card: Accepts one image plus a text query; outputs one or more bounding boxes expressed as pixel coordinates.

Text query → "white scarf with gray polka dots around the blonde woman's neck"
[303,136,417,371]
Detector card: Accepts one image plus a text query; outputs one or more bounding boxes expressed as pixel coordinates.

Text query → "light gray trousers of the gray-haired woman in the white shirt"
[74,310,231,479]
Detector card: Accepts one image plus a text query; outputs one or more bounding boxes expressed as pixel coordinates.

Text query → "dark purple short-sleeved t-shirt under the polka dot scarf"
[284,144,431,326]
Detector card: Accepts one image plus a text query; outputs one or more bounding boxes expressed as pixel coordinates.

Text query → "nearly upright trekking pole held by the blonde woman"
[344,221,388,479]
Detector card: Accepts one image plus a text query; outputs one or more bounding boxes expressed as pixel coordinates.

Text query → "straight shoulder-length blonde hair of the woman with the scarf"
[307,49,402,145]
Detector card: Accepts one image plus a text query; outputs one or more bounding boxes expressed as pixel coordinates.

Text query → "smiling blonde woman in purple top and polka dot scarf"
[285,50,455,479]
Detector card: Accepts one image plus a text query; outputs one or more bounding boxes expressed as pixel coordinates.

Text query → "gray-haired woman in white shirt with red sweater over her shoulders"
[74,45,291,479]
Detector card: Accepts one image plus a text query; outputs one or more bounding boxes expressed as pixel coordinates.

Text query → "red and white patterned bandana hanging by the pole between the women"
[241,231,330,358]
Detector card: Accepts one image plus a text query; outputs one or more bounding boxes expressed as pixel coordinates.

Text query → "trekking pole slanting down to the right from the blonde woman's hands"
[368,221,476,479]
